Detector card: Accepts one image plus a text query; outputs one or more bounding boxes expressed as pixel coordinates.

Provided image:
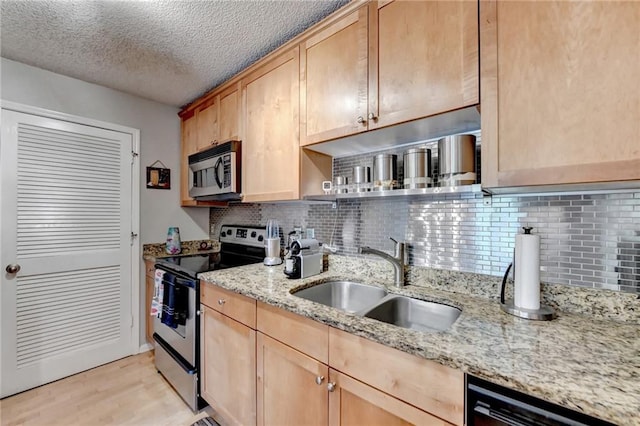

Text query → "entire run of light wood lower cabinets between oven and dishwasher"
[201,292,464,426]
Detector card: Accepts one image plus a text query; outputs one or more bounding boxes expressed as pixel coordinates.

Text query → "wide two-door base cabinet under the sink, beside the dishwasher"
[256,303,464,425]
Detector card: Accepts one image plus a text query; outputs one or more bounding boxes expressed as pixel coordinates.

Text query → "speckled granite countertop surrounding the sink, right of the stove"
[199,255,640,425]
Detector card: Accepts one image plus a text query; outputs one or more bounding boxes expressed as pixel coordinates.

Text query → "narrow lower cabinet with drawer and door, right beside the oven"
[200,283,256,425]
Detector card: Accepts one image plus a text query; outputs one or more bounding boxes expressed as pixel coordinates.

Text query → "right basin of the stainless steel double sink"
[364,296,461,332]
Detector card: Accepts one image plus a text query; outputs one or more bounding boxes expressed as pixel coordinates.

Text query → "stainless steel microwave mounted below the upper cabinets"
[189,141,242,201]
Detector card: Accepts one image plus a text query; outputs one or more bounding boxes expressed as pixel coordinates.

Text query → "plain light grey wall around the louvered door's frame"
[0,58,209,342]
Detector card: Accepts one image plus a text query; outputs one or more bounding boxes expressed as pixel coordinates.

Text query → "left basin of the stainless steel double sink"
[293,281,387,313]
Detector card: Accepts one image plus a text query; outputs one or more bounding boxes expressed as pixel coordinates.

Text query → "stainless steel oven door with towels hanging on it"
[153,265,199,366]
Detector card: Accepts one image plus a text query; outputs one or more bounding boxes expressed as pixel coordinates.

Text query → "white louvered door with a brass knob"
[0,110,133,397]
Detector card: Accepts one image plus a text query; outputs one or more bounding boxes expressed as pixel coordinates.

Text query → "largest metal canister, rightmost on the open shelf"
[438,135,476,186]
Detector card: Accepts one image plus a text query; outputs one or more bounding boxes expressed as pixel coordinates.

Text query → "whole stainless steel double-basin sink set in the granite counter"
[292,281,461,332]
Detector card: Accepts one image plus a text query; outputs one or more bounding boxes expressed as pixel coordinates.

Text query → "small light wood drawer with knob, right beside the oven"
[200,281,256,330]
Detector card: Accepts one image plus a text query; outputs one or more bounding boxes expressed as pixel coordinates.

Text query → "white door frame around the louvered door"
[0,99,141,356]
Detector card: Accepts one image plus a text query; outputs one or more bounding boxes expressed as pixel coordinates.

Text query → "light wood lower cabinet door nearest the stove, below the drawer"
[200,305,256,425]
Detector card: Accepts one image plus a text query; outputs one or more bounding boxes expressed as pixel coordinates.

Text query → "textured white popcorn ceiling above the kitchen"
[0,0,348,106]
